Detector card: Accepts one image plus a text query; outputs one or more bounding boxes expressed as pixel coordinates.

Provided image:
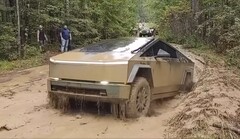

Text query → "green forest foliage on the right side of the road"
[148,0,240,66]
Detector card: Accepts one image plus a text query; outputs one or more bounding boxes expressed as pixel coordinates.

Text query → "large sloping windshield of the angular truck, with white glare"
[80,38,151,52]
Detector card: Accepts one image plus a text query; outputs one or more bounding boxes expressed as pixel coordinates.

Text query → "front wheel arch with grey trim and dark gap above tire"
[127,64,154,88]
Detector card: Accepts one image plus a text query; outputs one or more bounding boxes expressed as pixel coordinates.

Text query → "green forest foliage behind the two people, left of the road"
[0,0,137,60]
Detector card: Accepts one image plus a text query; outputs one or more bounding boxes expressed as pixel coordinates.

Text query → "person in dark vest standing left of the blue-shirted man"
[37,25,48,51]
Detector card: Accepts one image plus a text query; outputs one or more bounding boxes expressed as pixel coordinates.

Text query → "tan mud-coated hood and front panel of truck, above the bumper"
[49,51,133,83]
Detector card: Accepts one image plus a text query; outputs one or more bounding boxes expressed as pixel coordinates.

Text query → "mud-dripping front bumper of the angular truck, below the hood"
[48,79,131,103]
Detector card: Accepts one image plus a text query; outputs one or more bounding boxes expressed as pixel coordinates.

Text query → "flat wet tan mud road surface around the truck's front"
[0,66,182,138]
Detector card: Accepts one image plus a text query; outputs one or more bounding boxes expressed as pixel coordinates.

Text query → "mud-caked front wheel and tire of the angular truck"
[126,77,151,118]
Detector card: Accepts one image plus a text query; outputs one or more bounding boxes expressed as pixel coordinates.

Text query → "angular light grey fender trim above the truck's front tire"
[127,64,151,83]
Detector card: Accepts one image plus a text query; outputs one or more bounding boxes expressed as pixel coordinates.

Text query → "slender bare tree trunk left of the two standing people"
[16,0,21,57]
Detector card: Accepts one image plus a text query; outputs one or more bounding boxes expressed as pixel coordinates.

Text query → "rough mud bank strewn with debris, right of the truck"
[167,67,240,138]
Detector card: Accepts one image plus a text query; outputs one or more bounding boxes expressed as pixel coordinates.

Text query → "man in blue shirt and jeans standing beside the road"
[60,25,72,52]
